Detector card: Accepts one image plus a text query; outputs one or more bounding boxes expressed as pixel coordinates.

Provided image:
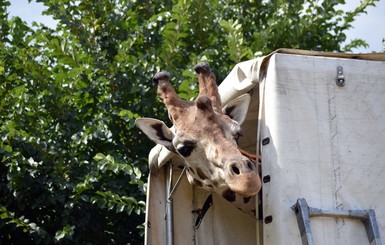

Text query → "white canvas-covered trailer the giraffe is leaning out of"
[145,49,385,245]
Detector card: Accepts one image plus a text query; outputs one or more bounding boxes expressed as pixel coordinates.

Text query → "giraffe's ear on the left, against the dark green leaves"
[135,118,175,152]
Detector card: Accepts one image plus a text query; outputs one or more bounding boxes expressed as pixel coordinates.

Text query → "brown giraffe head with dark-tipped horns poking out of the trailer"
[136,63,261,216]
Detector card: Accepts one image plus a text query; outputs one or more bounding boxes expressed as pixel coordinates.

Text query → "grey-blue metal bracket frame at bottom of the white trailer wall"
[292,198,382,245]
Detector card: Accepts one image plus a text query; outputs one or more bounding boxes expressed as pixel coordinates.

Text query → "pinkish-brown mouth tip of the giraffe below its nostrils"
[226,173,262,197]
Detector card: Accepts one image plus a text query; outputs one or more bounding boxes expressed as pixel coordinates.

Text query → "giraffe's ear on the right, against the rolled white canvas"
[222,94,250,125]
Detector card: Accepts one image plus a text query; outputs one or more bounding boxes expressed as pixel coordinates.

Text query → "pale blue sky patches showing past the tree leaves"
[8,0,385,53]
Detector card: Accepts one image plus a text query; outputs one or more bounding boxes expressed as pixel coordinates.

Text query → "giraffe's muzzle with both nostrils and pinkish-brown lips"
[225,159,262,196]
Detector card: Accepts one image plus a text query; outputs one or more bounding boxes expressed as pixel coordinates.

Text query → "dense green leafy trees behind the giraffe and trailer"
[0,0,375,244]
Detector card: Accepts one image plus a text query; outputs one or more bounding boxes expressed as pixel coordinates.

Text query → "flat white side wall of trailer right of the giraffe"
[262,54,385,245]
